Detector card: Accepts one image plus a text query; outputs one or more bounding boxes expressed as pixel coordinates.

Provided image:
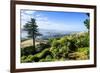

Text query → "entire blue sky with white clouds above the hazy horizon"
[20,10,88,31]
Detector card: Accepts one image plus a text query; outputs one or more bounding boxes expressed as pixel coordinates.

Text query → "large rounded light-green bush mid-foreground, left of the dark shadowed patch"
[51,38,68,60]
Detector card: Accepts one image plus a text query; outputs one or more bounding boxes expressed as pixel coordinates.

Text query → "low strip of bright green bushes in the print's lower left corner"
[21,49,52,63]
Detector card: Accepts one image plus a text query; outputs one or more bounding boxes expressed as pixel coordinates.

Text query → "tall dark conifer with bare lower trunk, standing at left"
[24,18,40,48]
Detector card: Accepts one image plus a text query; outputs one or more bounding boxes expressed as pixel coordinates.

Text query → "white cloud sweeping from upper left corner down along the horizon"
[21,11,83,31]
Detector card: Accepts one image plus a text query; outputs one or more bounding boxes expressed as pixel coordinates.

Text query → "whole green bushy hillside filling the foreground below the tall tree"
[21,33,89,63]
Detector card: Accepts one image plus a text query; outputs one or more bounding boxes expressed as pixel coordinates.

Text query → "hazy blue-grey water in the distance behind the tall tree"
[21,29,78,38]
